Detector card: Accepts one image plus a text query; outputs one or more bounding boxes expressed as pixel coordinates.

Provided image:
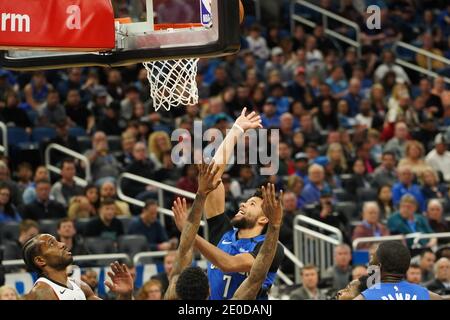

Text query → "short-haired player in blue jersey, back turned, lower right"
[354,241,442,300]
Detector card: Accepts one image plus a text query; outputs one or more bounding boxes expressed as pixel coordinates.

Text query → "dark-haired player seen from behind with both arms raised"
[171,182,283,300]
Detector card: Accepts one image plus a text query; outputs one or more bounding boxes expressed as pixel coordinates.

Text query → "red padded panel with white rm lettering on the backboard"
[0,0,115,51]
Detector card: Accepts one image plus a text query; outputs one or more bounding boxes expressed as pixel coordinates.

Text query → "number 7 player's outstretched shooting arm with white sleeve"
[205,108,262,218]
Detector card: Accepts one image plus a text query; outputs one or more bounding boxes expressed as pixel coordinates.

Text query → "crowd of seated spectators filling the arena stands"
[0,0,450,299]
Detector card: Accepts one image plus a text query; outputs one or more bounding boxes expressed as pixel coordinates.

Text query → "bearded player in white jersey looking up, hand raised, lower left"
[22,234,133,300]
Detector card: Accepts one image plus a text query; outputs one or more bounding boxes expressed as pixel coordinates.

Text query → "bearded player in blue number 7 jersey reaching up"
[172,108,284,300]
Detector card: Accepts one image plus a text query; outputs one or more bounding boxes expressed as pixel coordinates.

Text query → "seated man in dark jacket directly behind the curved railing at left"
[50,159,83,207]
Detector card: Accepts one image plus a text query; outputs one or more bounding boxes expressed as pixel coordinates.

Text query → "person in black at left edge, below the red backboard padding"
[0,90,33,133]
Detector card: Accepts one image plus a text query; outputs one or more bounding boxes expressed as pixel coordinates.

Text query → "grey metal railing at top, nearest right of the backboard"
[291,0,361,57]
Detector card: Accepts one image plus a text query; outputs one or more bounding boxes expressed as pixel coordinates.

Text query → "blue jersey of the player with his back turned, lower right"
[361,281,430,300]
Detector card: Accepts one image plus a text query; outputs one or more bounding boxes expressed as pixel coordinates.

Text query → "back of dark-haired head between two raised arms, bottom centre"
[175,267,209,300]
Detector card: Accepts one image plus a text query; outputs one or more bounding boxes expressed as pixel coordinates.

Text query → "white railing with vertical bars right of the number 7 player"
[294,215,343,283]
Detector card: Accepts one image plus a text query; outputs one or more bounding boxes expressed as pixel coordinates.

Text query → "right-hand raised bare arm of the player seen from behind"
[233,183,283,300]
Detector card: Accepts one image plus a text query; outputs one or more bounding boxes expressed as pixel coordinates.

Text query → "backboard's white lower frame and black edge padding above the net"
[0,0,240,71]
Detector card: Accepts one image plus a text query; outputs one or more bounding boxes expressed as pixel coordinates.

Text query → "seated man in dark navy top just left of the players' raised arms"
[128,200,176,251]
